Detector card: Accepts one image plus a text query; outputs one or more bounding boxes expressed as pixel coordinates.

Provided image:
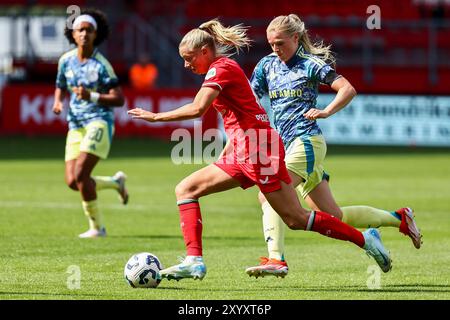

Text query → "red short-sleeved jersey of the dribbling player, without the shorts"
[202,57,270,132]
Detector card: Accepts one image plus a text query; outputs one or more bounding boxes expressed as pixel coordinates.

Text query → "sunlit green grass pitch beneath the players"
[0,137,450,300]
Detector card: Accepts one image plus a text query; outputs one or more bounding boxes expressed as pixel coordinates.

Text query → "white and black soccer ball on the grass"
[123,252,163,288]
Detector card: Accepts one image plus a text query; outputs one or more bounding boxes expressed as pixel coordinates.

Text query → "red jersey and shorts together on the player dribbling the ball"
[202,57,291,193]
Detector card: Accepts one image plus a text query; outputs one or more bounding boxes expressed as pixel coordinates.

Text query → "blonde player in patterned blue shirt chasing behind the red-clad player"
[246,14,422,277]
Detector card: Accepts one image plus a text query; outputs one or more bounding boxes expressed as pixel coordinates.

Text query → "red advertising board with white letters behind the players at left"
[0,85,217,138]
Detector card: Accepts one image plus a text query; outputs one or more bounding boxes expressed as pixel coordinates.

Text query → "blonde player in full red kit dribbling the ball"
[128,20,391,280]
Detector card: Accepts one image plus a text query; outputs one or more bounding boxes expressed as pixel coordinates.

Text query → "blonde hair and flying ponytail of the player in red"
[180,19,252,57]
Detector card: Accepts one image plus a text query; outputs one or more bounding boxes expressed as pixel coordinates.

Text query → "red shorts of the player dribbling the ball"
[214,129,291,193]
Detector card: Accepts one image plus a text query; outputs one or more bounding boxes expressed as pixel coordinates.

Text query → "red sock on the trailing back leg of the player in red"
[307,211,365,248]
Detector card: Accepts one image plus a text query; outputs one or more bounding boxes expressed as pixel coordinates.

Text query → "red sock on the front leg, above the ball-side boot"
[178,202,203,256]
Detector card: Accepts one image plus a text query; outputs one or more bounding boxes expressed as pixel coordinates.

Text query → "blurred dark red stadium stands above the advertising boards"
[0,0,450,95]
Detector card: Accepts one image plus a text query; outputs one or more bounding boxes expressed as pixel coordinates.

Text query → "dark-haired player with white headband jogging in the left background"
[53,10,128,238]
